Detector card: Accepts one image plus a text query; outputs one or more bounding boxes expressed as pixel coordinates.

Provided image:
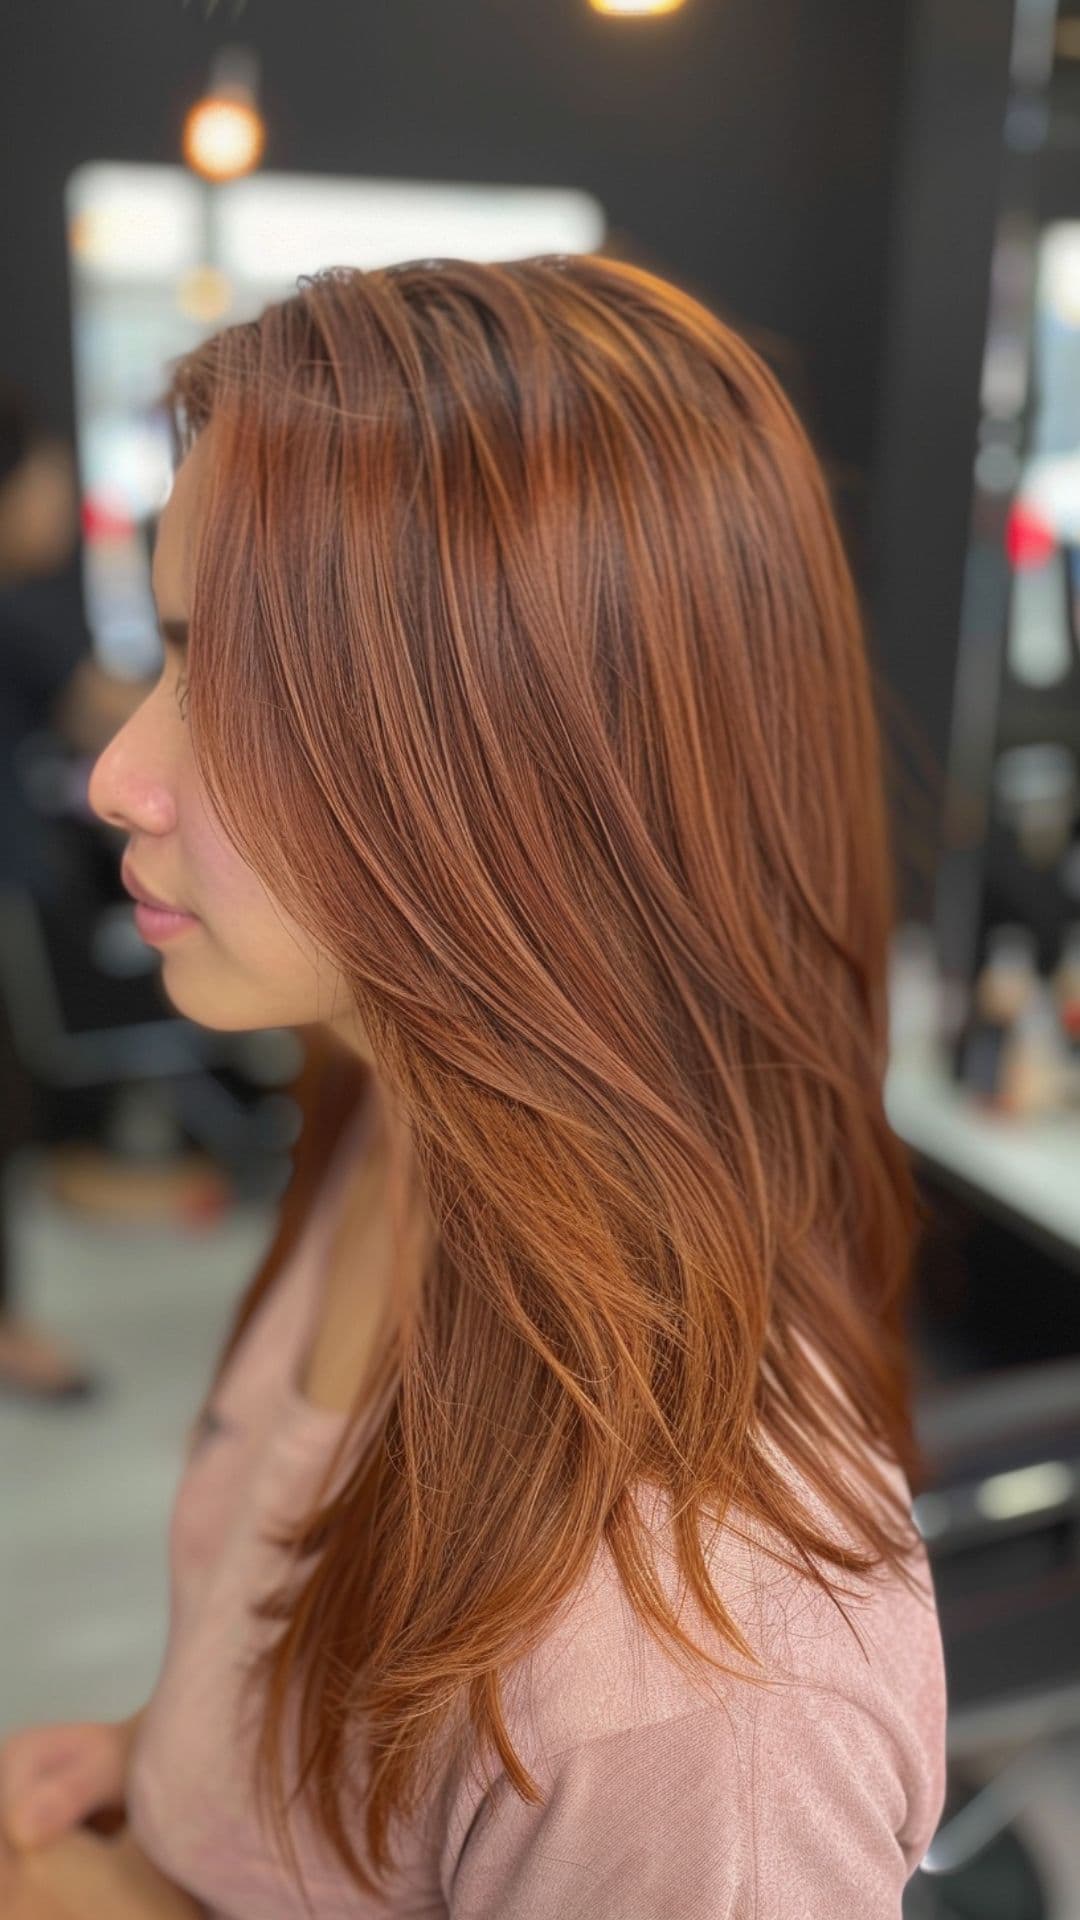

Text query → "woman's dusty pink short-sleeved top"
[129,1129,945,1920]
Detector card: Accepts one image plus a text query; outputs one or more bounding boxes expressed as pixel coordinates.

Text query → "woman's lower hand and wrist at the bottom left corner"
[0,1828,206,1920]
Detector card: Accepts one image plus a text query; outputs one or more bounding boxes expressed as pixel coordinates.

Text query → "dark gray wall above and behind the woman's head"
[0,0,907,576]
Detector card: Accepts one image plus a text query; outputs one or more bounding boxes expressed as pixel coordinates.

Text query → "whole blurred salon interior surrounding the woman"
[0,0,1080,1920]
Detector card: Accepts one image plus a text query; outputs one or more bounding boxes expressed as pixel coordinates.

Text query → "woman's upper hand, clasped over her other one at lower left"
[0,1715,138,1847]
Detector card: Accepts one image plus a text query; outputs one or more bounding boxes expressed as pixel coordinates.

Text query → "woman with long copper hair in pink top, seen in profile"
[0,255,945,1920]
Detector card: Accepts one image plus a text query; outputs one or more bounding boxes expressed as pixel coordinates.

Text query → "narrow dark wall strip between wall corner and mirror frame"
[867,0,1013,914]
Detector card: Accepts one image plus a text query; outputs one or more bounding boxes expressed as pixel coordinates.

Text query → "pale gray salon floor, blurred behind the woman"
[0,1150,1080,1920]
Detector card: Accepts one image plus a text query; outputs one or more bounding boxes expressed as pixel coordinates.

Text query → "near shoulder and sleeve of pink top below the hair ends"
[434,1469,945,1920]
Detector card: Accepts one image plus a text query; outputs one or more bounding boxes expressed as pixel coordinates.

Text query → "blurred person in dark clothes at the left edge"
[0,384,96,1398]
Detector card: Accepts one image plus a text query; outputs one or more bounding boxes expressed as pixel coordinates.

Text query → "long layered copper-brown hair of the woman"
[157,253,926,1889]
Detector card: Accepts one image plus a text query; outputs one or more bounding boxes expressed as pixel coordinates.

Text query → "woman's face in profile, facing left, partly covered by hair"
[88,428,363,1052]
